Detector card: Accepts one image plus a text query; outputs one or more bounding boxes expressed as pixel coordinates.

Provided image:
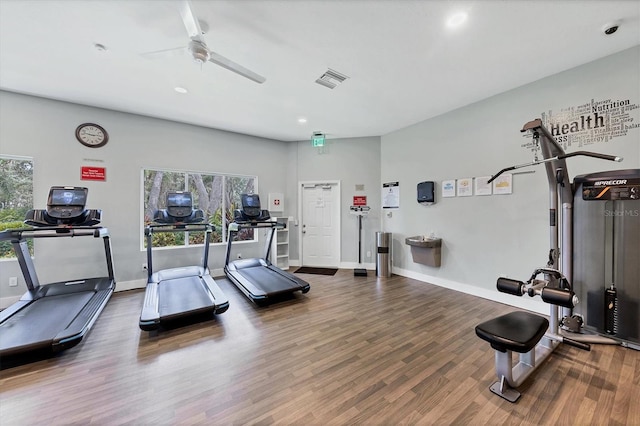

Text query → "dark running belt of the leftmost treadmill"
[0,291,95,351]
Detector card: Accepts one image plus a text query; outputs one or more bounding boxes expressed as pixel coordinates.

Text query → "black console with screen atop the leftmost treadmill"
[24,186,102,227]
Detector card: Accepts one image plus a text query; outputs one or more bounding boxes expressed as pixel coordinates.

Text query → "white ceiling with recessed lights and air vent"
[0,0,640,141]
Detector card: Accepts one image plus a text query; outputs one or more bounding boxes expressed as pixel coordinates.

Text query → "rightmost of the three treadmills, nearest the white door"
[224,194,311,305]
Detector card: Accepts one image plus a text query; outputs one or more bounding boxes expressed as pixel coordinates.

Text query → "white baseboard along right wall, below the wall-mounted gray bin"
[392,267,549,315]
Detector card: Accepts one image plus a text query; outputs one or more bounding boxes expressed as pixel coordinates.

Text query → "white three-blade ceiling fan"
[143,0,266,84]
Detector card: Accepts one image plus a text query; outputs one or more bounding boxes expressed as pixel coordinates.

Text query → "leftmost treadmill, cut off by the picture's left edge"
[0,186,115,357]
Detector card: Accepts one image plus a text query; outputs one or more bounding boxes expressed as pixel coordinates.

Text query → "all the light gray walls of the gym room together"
[0,47,640,312]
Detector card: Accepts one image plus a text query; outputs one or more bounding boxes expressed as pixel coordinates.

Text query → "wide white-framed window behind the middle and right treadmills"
[143,170,257,247]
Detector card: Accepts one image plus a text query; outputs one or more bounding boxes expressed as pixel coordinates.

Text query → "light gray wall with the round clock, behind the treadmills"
[0,91,289,300]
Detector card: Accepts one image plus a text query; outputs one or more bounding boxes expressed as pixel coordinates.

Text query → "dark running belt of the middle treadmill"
[158,276,213,318]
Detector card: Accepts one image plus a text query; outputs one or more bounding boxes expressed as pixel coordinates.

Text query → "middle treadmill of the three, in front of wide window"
[140,191,229,331]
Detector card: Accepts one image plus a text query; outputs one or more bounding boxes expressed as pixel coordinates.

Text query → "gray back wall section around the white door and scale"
[287,136,380,268]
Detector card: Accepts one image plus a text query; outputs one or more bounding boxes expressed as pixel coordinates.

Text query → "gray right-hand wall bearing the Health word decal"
[381,47,640,312]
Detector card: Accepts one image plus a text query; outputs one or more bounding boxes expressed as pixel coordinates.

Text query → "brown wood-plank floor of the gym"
[0,270,640,426]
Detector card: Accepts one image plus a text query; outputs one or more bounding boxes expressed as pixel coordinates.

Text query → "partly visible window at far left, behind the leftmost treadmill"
[0,156,33,259]
